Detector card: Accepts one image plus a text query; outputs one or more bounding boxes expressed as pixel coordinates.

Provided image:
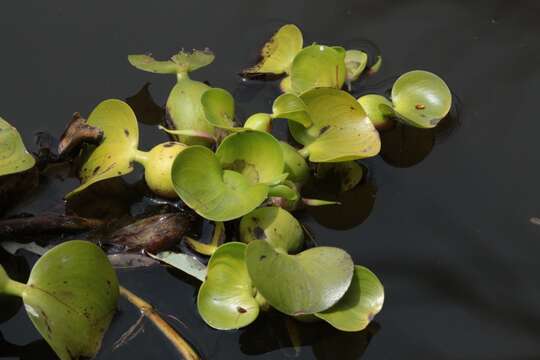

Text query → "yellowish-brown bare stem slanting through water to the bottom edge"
[120,286,200,360]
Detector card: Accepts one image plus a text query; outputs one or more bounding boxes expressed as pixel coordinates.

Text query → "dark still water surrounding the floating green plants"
[0,0,540,360]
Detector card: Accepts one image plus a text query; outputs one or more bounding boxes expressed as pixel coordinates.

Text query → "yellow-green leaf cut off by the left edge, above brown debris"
[0,117,36,176]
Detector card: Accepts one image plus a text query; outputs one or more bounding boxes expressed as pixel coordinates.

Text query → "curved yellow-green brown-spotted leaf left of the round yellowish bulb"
[66,99,139,198]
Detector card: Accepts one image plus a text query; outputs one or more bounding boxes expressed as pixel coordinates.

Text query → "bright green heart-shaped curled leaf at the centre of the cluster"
[172,130,286,221]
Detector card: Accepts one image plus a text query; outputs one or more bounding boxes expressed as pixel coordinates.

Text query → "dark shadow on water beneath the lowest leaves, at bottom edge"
[239,311,380,360]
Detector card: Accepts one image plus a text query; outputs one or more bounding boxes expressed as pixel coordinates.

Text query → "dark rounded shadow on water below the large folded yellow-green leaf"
[302,169,377,230]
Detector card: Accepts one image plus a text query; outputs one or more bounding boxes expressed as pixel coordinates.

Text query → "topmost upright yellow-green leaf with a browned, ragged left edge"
[243,24,304,75]
